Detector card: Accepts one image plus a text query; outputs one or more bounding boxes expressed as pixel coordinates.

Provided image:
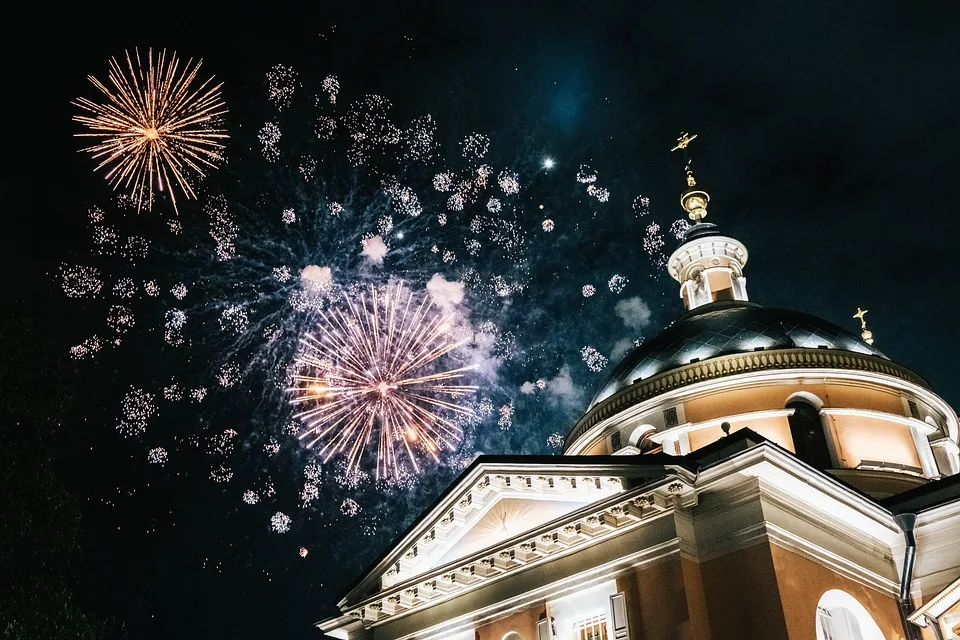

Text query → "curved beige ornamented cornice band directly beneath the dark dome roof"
[565,348,932,452]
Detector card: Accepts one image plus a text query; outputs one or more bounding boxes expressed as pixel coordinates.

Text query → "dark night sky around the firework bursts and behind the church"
[0,0,960,638]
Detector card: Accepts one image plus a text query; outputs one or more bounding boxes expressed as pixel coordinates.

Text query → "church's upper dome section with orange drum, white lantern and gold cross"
[563,133,960,497]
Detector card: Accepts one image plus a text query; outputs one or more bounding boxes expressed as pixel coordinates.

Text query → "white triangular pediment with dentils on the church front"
[341,456,668,606]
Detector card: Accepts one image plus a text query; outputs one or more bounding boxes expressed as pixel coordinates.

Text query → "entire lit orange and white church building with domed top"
[317,141,960,640]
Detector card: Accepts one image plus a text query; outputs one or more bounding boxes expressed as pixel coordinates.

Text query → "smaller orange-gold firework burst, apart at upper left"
[73,49,228,210]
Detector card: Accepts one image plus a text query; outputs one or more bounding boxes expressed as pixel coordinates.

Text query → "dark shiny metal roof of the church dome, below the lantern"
[590,301,886,406]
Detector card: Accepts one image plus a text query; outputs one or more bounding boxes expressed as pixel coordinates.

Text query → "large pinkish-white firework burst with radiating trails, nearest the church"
[290,284,477,479]
